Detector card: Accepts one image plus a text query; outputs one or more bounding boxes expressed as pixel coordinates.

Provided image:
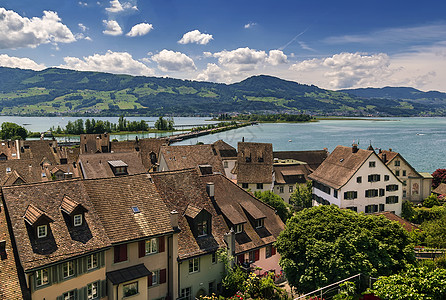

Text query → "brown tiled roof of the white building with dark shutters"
[309,146,379,189]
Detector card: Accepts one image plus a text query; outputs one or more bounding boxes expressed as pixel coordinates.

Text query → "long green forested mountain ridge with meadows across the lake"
[0,67,446,116]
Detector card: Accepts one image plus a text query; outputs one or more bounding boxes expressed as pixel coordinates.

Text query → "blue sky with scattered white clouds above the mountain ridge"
[0,0,446,92]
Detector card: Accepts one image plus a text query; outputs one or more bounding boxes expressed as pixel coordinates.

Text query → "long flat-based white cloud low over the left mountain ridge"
[59,50,154,76]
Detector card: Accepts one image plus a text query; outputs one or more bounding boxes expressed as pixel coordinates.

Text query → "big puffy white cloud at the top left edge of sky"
[0,8,76,49]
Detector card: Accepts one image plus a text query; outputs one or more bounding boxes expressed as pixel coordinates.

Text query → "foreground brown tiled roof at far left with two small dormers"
[2,180,110,272]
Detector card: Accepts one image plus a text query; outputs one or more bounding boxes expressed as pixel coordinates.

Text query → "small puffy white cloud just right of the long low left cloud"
[152,49,197,72]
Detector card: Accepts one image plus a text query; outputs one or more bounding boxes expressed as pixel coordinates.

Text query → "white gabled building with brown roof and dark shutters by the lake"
[309,145,403,215]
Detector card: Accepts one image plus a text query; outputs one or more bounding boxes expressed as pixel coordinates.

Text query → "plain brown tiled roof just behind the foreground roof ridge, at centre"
[160,145,225,174]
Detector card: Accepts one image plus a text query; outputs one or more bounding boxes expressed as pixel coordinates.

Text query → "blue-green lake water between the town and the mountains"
[0,116,446,173]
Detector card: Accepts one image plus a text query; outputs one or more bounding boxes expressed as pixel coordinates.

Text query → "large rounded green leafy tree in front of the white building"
[276,205,415,293]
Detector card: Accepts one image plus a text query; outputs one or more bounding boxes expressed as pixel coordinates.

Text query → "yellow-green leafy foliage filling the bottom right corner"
[368,267,446,300]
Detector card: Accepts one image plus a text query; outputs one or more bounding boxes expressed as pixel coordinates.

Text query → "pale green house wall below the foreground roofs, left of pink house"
[178,254,224,297]
